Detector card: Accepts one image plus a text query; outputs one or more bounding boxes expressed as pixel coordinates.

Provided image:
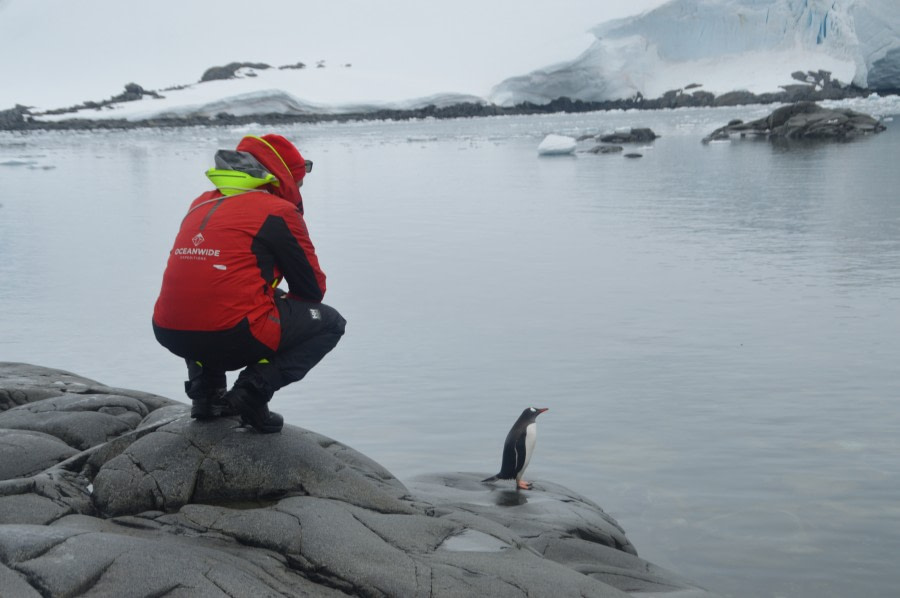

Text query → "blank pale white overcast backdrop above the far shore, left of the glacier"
[0,0,665,109]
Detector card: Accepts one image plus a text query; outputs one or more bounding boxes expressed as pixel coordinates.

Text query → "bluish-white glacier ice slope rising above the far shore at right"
[490,0,900,105]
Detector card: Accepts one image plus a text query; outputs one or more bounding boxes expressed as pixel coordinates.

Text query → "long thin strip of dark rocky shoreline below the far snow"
[0,71,884,131]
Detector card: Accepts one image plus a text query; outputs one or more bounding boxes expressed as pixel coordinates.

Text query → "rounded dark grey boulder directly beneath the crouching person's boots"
[94,417,411,515]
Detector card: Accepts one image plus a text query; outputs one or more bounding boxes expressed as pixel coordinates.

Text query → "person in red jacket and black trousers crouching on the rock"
[153,134,346,433]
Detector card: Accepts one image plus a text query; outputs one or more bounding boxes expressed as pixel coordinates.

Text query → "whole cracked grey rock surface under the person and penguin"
[0,363,711,598]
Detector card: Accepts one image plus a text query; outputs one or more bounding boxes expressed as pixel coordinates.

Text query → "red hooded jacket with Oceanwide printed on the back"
[153,137,325,351]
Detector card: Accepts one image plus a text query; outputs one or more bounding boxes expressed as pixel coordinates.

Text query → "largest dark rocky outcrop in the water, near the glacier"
[703,102,885,143]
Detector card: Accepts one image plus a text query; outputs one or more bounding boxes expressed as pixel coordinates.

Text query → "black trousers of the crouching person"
[154,298,347,401]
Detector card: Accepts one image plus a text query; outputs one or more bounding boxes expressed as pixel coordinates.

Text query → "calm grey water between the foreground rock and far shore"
[0,103,900,598]
